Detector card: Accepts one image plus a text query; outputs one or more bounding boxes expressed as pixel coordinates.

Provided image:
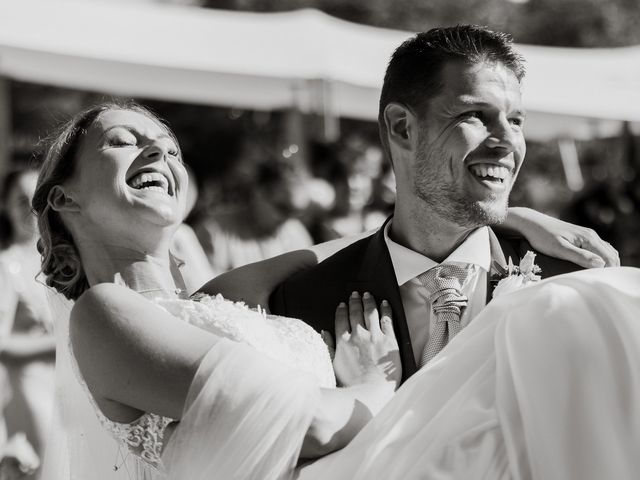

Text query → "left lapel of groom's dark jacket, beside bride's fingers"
[347,218,417,382]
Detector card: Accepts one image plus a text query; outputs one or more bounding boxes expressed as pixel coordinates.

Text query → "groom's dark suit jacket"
[269,220,581,382]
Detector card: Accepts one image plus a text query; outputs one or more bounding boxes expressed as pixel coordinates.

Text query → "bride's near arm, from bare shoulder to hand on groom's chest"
[70,284,400,457]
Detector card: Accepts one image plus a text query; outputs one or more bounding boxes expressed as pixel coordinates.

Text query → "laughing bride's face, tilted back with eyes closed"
[65,110,188,242]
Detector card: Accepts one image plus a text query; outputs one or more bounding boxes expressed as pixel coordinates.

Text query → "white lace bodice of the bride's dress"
[91,294,336,470]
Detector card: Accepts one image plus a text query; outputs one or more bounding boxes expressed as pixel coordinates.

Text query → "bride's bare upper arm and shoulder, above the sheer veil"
[69,283,219,423]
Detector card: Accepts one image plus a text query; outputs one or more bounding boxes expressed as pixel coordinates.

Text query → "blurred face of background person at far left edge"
[6,170,38,241]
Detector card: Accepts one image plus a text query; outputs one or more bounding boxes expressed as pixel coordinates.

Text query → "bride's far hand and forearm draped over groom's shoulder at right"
[499,207,620,268]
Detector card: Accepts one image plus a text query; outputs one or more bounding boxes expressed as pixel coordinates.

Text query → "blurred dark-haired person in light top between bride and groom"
[194,154,313,274]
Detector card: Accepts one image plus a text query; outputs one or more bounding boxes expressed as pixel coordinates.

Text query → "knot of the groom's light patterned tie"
[418,263,469,315]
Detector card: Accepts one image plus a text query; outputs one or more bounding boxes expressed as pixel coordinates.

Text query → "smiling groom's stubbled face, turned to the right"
[413,62,526,228]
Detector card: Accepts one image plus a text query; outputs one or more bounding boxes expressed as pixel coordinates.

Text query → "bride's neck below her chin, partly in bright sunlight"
[79,244,186,298]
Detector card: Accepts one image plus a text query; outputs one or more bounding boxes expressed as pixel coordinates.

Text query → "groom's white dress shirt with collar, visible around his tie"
[384,222,491,364]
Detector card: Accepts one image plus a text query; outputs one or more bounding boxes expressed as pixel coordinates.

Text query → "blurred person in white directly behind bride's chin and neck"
[171,163,214,294]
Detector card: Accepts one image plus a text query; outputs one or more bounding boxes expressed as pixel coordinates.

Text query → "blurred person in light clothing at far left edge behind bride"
[0,168,55,476]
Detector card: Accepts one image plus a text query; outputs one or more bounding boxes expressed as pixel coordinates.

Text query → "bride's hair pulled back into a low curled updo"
[32,102,173,300]
